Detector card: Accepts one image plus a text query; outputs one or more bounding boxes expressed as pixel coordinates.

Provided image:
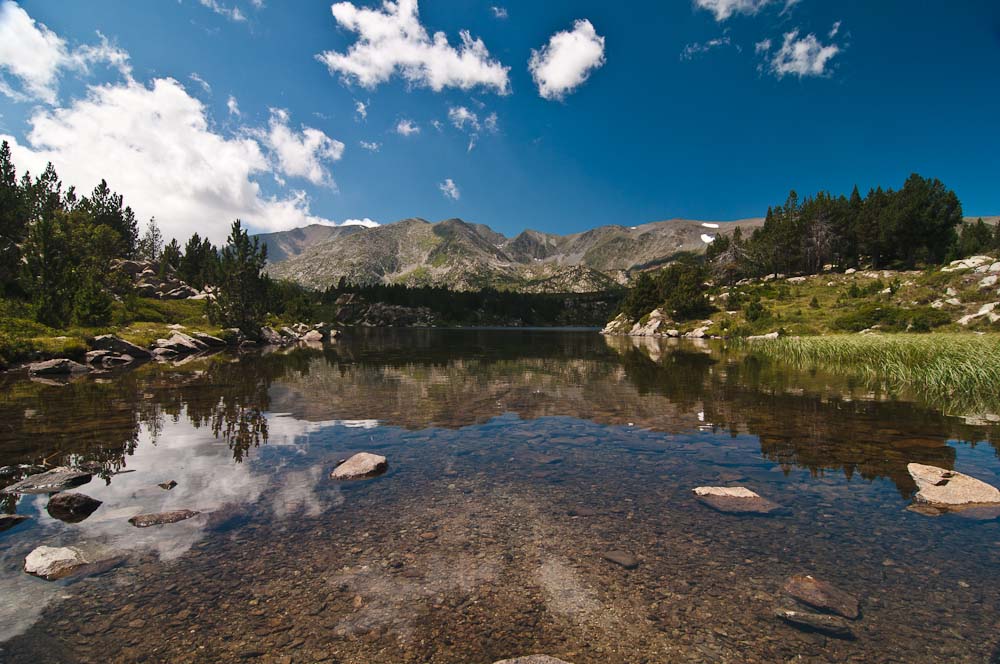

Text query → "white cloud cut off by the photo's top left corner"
[0,0,131,104]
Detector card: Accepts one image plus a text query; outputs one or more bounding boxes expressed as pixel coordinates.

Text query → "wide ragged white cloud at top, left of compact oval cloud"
[316,0,510,94]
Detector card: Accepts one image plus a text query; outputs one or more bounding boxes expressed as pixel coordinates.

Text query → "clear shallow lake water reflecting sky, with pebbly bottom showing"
[0,331,1000,664]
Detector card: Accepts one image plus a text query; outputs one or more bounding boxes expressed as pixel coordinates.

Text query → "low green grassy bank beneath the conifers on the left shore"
[0,298,220,363]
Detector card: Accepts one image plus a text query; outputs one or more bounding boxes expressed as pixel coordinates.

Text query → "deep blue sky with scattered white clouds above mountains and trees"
[0,0,1000,244]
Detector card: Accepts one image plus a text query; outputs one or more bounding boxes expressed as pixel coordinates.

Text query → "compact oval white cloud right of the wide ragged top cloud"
[528,19,604,100]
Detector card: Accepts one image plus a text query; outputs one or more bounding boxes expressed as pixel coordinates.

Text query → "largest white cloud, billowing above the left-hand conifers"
[0,78,342,242]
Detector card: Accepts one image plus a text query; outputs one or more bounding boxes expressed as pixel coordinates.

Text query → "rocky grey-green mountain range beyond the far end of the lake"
[259,218,763,293]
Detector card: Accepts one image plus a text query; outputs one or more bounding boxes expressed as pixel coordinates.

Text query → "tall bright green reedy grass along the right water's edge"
[740,333,1000,414]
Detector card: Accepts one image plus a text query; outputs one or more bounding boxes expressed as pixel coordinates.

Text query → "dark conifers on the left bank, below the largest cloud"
[0,141,274,334]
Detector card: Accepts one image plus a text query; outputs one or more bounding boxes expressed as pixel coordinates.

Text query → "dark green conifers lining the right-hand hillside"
[622,174,1000,320]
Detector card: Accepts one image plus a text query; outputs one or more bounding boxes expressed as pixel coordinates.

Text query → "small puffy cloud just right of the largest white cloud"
[253,108,344,187]
